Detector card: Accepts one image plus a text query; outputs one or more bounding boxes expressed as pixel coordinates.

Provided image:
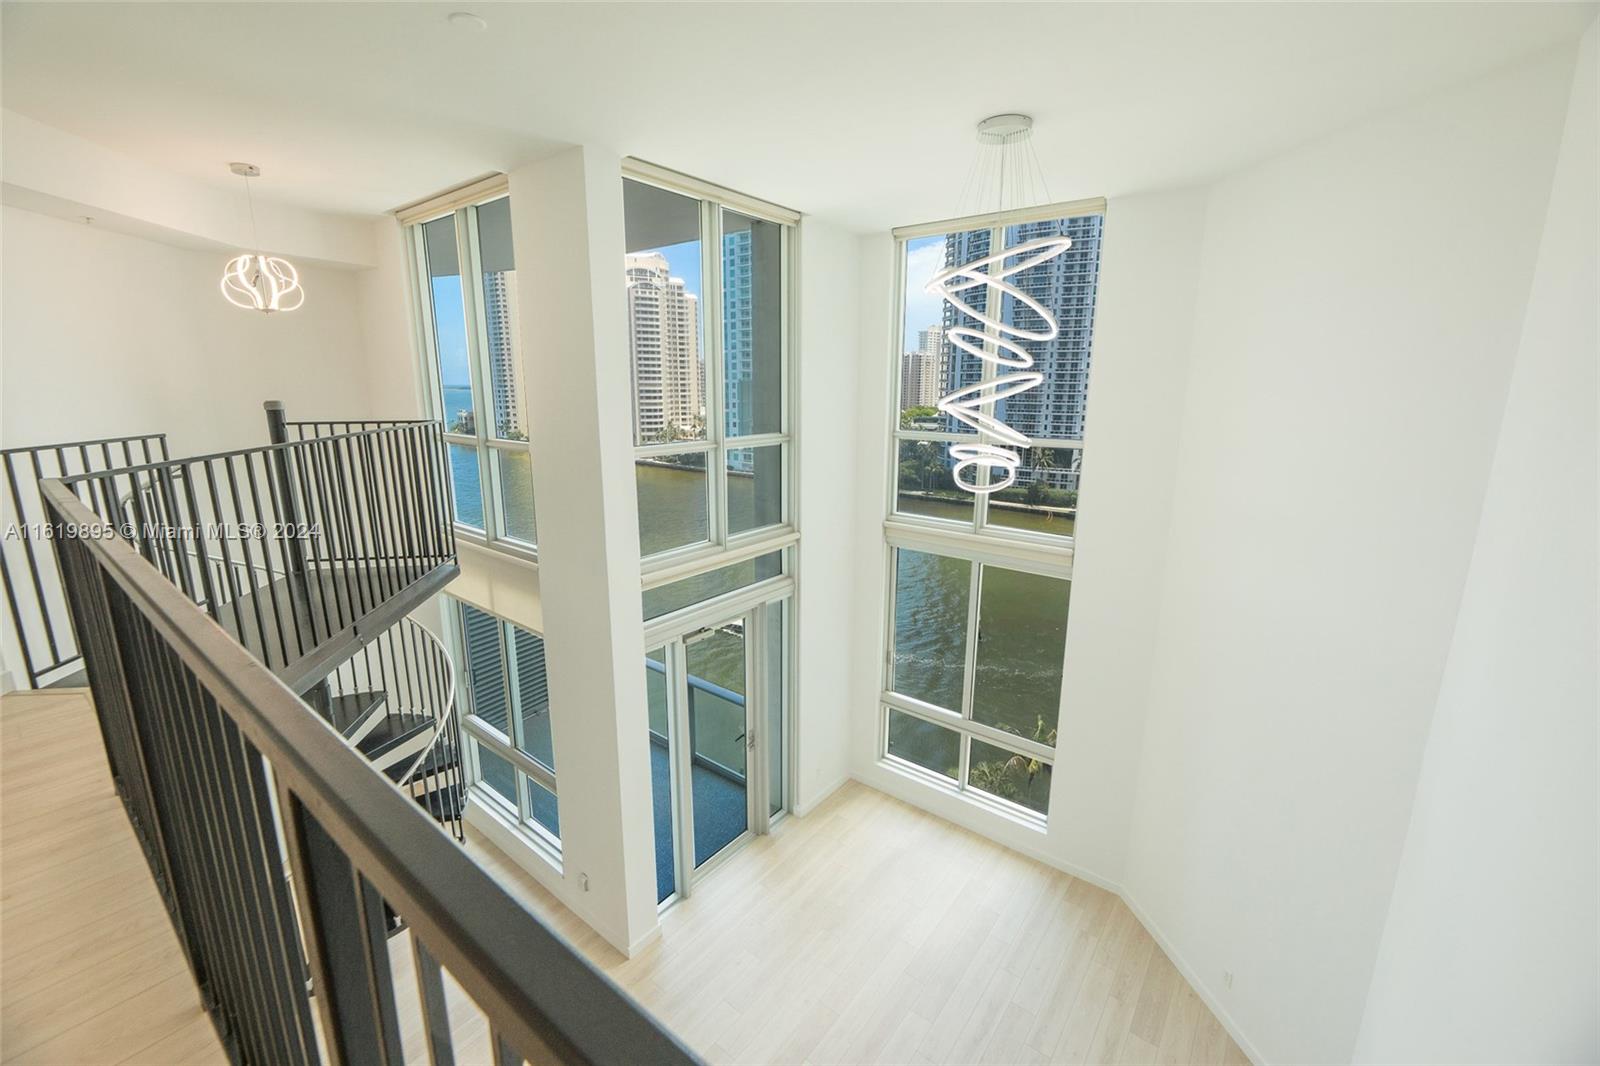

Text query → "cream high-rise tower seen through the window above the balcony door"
[626,251,706,443]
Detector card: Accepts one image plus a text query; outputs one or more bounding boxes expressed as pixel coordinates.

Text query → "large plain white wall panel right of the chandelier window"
[1120,43,1571,1063]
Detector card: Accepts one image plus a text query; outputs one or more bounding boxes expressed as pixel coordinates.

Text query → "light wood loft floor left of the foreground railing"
[0,690,227,1066]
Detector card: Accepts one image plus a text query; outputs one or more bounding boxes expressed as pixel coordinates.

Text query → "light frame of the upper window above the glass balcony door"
[621,157,802,589]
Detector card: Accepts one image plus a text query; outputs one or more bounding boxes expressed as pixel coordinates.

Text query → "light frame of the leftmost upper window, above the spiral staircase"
[395,174,539,563]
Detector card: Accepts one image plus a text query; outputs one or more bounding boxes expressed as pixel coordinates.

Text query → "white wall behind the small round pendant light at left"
[0,206,371,456]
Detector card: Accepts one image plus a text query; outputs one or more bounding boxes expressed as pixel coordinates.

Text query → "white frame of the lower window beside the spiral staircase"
[443,592,562,868]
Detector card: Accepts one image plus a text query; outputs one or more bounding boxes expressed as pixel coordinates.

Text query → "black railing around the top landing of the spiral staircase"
[64,423,458,691]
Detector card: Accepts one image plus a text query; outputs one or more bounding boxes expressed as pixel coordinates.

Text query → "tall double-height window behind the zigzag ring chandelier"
[878,202,1104,826]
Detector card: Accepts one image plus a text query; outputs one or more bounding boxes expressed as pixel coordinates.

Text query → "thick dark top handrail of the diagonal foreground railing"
[40,479,696,1063]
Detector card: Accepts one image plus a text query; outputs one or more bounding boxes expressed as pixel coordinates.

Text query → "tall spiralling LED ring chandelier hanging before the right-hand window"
[925,115,1072,495]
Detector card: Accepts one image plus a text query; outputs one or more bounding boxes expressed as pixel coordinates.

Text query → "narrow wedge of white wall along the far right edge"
[1355,29,1600,1063]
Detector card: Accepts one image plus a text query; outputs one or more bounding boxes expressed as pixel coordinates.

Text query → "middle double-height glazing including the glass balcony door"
[622,163,798,903]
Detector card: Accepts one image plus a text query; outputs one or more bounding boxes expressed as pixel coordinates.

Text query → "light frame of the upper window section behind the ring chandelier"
[885,197,1106,552]
